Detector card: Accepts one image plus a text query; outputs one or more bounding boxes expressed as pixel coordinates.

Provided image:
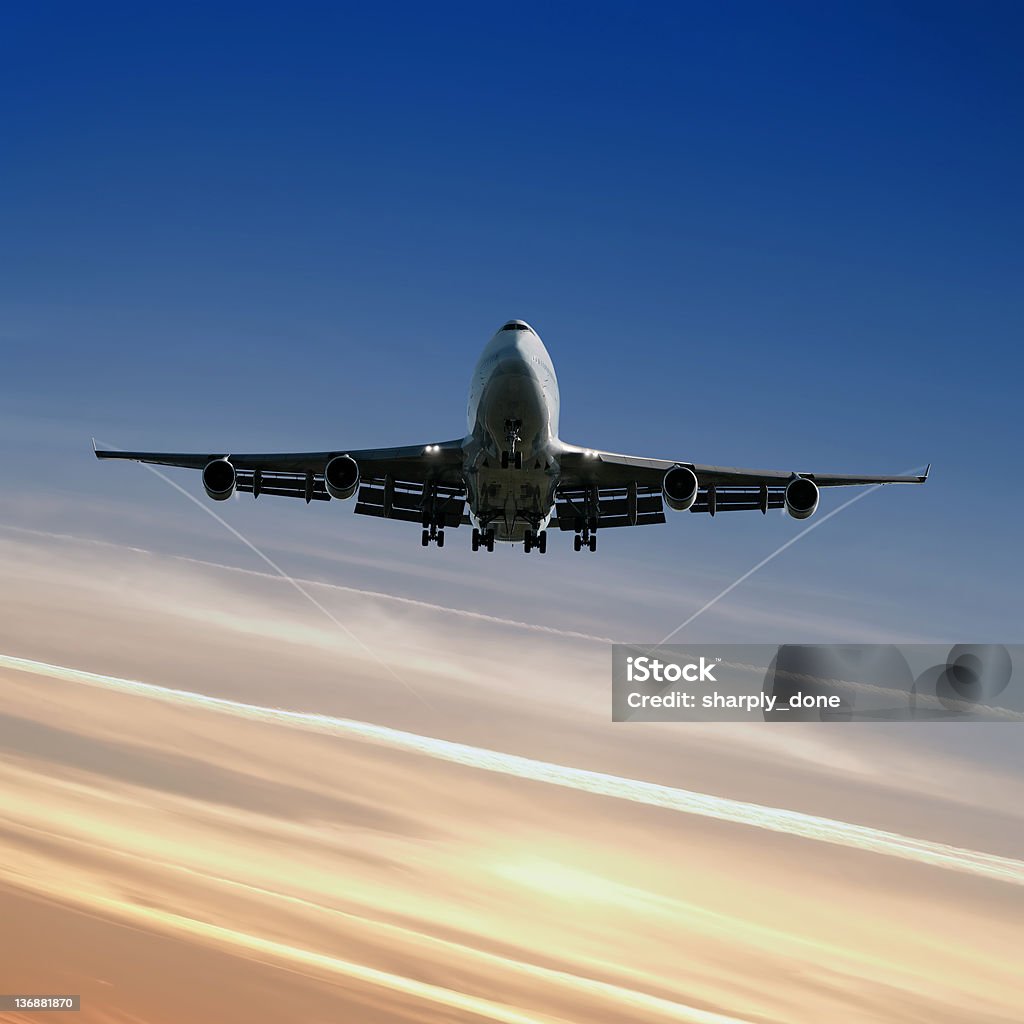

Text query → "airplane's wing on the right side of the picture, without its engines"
[557,445,931,529]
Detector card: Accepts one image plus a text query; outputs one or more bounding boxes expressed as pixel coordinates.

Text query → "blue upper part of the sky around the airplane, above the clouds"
[0,3,1024,640]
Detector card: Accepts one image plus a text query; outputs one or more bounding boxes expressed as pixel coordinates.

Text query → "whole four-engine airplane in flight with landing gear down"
[93,319,931,554]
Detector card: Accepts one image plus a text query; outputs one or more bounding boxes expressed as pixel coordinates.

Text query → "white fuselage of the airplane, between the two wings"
[463,321,562,541]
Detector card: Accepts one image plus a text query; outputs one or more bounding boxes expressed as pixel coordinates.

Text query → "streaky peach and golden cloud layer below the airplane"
[0,534,1024,1024]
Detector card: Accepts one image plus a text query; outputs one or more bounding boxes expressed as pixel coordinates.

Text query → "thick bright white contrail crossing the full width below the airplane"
[0,654,1024,886]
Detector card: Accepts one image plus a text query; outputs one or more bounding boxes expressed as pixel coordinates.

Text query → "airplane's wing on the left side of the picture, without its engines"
[93,438,465,526]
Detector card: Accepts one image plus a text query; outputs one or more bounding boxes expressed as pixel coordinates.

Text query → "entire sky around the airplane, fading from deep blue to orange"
[0,3,1024,1024]
